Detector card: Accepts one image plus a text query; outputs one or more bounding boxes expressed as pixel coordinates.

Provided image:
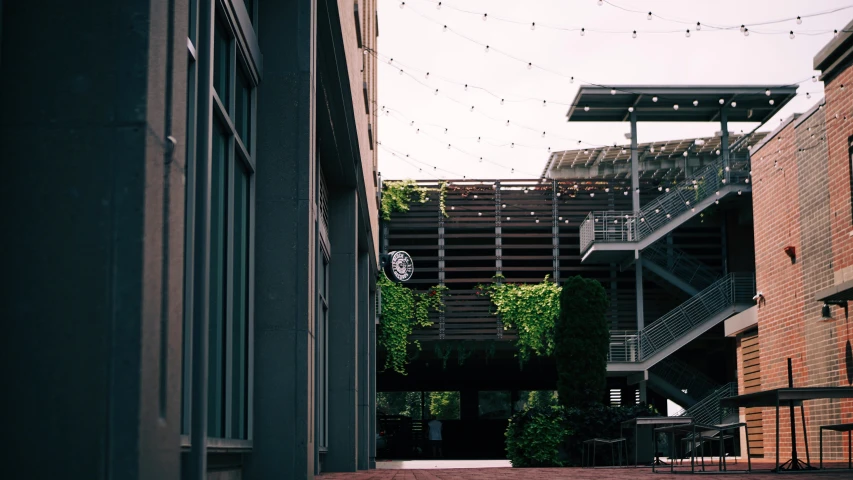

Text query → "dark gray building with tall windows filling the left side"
[0,0,378,480]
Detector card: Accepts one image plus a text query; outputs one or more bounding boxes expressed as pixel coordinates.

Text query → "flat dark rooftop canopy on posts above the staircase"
[566,85,797,123]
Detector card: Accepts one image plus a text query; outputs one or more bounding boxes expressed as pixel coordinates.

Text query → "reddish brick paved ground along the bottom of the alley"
[318,464,853,480]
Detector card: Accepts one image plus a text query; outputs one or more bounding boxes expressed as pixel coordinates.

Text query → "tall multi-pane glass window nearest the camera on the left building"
[182,0,258,446]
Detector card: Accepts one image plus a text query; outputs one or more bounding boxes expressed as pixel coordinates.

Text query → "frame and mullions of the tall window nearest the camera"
[181,0,261,450]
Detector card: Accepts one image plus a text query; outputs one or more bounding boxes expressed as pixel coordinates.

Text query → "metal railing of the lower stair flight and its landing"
[608,273,755,362]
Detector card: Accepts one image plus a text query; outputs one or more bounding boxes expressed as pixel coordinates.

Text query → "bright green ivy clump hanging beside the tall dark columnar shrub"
[477,276,560,363]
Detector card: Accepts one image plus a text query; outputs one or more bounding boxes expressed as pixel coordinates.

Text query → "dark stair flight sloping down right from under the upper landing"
[642,242,720,295]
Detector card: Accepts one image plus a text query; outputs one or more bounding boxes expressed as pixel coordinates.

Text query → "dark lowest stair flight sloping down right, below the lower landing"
[649,356,720,408]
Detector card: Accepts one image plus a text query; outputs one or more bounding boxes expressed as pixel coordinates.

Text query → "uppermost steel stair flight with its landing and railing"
[580,159,751,262]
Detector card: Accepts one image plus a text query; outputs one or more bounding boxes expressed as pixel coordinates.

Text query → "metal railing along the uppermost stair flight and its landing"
[580,159,749,254]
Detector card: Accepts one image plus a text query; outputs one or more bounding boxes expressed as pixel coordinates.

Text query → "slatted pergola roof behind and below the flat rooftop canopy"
[542,132,767,178]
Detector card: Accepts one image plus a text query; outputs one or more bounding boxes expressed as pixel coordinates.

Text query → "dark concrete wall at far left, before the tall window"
[0,0,187,480]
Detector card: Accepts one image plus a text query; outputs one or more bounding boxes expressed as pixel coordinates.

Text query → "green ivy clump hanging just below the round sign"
[377,273,447,375]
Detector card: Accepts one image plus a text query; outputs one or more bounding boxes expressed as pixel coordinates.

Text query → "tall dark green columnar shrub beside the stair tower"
[554,276,610,407]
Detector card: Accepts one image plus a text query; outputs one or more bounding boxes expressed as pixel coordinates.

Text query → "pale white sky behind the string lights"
[377,0,853,180]
